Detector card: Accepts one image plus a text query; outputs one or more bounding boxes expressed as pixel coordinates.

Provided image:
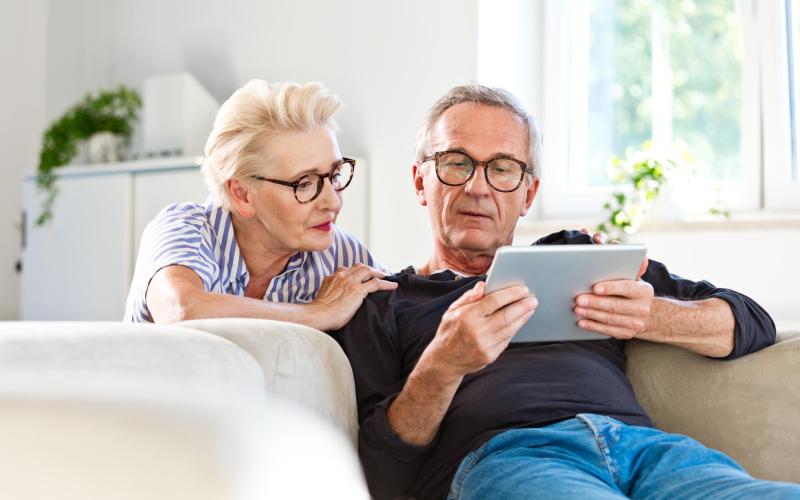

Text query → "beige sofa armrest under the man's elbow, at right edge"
[627,331,800,482]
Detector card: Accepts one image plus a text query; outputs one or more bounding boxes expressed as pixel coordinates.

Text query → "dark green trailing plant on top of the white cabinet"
[36,85,142,226]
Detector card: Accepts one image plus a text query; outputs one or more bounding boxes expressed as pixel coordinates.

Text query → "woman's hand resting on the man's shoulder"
[310,264,397,331]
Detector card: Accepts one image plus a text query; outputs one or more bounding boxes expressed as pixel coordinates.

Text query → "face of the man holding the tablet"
[413,103,539,255]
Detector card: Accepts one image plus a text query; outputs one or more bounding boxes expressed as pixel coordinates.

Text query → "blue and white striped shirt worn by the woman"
[124,198,381,322]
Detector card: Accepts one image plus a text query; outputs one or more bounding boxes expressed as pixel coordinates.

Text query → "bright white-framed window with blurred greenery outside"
[479,0,800,216]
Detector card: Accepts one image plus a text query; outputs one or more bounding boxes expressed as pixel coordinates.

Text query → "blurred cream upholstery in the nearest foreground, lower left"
[0,390,369,500]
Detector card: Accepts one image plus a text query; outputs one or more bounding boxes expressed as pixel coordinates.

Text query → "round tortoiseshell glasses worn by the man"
[422,151,533,193]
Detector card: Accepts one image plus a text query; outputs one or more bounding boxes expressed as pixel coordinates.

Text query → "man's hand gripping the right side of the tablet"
[573,259,653,340]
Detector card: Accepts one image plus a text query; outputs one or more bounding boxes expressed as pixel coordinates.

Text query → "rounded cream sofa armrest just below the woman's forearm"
[180,318,358,443]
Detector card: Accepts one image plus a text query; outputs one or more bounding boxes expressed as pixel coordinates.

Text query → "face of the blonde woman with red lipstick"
[251,126,342,251]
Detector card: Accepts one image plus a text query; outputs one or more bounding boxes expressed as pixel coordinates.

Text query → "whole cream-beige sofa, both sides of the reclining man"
[0,319,800,499]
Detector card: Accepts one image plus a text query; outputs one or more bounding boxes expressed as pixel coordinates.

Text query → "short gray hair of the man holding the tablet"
[416,84,542,178]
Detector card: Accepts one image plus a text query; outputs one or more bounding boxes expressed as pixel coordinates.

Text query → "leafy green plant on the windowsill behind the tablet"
[597,141,686,241]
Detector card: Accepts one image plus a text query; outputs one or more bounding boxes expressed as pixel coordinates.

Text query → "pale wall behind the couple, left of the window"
[47,0,477,269]
